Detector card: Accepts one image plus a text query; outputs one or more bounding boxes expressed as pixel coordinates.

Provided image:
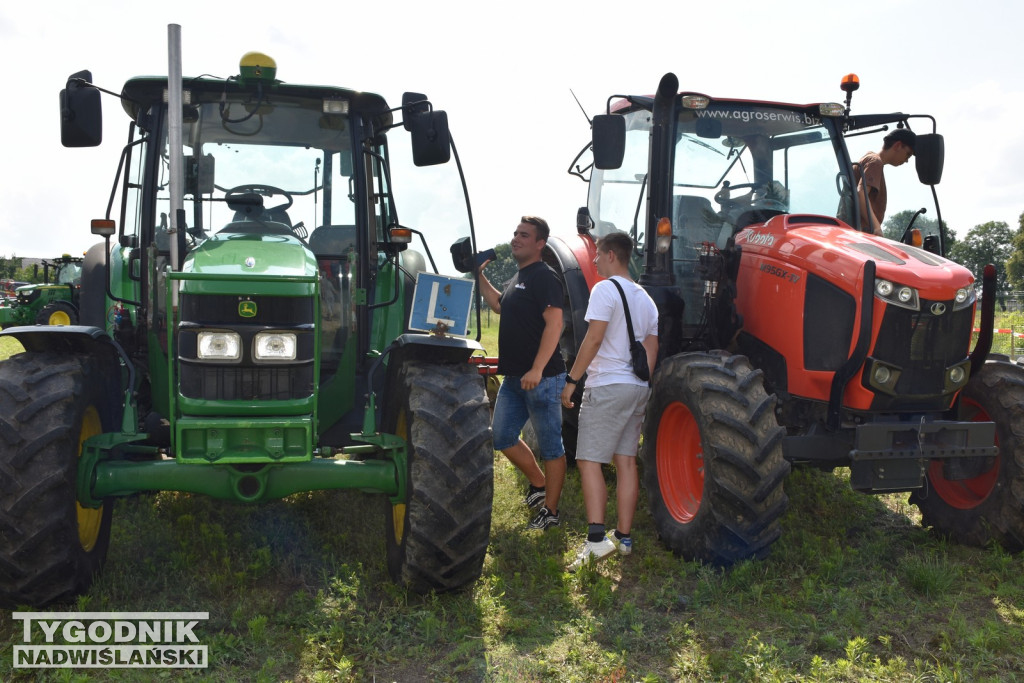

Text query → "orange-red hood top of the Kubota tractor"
[736,214,974,300]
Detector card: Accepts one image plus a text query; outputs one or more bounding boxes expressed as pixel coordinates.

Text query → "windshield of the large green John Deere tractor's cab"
[156,92,355,239]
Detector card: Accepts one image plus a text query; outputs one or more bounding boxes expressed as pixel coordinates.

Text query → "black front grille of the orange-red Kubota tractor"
[871,300,973,396]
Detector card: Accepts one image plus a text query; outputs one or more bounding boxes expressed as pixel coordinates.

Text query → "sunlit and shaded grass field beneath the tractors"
[0,317,1024,682]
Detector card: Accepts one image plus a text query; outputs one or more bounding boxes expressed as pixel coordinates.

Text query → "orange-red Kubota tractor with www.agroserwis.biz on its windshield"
[546,74,1024,565]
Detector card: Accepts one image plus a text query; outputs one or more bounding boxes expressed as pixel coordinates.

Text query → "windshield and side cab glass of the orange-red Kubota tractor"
[589,101,853,324]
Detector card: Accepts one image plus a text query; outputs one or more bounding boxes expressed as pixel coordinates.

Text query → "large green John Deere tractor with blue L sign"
[0,32,494,606]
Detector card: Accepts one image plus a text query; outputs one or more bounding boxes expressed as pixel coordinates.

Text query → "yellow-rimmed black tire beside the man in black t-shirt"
[384,361,495,593]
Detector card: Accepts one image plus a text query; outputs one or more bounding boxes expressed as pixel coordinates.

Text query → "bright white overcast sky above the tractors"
[0,0,1024,262]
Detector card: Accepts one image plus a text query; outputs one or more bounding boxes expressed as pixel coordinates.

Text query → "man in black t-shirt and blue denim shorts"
[480,216,565,529]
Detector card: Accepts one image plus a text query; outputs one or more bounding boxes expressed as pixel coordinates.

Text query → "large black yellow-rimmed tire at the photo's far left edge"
[0,352,113,607]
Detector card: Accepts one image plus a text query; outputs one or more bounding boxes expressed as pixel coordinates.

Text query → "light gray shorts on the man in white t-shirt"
[577,384,650,464]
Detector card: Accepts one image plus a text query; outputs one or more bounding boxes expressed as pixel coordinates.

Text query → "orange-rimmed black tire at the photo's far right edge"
[910,361,1024,552]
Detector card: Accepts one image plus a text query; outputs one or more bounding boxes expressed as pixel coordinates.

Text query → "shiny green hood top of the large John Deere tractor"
[181,233,317,296]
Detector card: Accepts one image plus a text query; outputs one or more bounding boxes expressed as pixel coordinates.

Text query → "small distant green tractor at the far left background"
[0,254,85,329]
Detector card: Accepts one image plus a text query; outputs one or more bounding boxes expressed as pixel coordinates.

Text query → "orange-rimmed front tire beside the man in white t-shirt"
[640,352,790,566]
